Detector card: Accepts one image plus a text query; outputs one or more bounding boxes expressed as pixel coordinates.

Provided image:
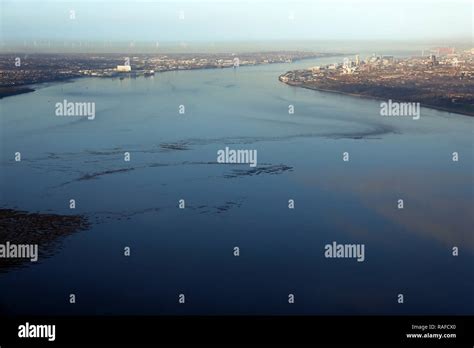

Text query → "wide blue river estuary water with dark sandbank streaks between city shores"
[0,58,474,314]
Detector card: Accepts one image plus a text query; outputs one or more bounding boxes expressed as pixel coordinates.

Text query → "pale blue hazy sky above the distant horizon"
[0,0,473,42]
